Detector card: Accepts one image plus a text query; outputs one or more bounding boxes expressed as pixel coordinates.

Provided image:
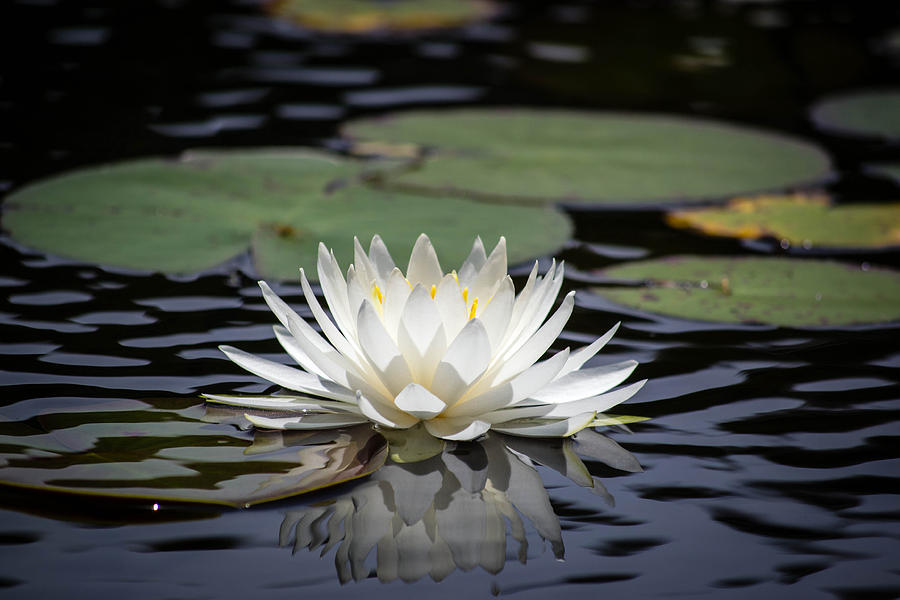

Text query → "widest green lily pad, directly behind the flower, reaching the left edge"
[3,150,571,279]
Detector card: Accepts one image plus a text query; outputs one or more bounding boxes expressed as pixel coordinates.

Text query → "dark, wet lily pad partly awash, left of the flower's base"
[0,406,388,507]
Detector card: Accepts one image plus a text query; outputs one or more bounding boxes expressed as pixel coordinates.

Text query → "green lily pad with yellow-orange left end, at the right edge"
[666,194,900,248]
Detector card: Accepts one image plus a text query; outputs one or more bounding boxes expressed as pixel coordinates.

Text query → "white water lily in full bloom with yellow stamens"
[206,234,646,440]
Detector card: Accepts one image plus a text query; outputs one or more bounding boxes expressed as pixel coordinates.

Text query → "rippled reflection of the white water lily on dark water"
[280,430,640,583]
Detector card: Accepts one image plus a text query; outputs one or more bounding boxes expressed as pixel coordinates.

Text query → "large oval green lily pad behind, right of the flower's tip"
[343,109,830,205]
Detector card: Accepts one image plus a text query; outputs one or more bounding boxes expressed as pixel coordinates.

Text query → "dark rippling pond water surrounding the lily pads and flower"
[0,0,900,599]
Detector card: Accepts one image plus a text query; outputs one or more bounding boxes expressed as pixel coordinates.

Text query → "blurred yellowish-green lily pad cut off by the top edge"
[268,0,496,33]
